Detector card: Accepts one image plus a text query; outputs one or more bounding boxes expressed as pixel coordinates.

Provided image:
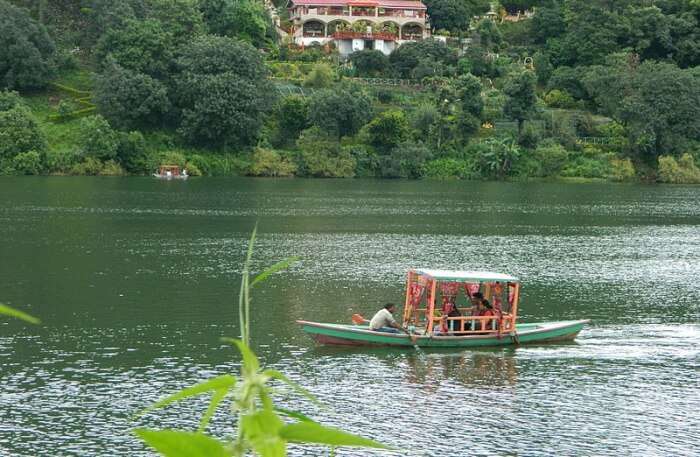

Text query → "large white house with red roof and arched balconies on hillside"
[289,0,430,56]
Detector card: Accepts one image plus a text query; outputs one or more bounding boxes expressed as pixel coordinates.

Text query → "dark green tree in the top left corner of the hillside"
[0,0,56,89]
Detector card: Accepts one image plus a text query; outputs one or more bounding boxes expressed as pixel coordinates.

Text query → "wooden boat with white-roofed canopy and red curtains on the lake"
[297,269,589,348]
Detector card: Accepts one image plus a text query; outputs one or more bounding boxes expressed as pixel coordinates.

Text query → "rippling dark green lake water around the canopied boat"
[0,178,700,456]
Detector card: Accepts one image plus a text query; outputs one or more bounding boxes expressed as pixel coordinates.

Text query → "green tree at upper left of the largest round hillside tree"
[95,19,173,79]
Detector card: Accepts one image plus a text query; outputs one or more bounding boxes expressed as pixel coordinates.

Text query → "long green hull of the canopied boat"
[297,320,589,348]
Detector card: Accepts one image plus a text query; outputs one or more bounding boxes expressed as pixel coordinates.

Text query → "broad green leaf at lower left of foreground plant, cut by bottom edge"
[134,428,232,457]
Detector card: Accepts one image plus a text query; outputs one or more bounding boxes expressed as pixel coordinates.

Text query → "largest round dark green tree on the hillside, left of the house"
[176,35,273,146]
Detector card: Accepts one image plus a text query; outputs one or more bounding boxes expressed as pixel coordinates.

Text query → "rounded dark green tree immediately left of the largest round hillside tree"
[95,61,170,128]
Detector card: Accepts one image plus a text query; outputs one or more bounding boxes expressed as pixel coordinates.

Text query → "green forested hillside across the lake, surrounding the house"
[0,0,700,183]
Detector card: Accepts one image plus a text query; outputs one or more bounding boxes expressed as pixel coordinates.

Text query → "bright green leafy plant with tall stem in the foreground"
[134,226,388,457]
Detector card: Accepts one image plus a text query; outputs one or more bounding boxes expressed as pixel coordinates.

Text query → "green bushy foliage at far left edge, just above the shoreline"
[0,101,46,160]
